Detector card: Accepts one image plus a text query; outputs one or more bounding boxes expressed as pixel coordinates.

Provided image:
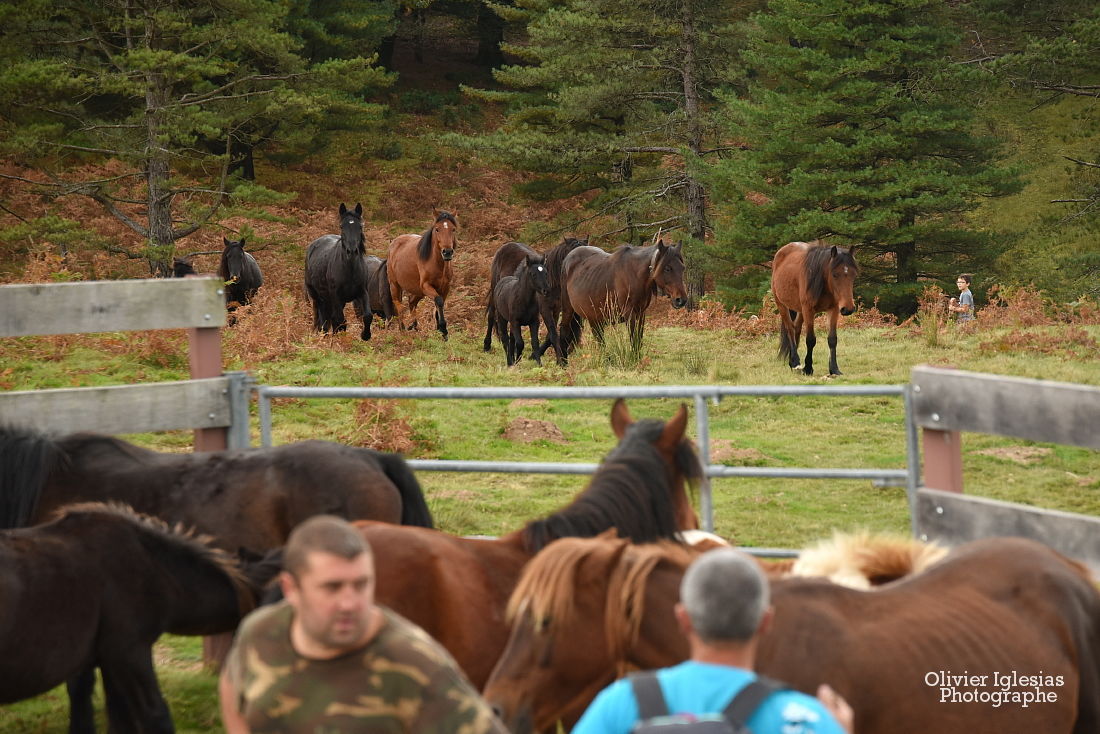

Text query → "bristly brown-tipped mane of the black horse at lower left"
[54,502,255,616]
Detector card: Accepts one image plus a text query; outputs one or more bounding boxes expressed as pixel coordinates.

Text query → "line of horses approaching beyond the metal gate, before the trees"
[174,204,859,375]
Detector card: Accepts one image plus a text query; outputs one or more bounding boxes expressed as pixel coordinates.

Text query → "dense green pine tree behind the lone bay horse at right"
[713,0,1020,315]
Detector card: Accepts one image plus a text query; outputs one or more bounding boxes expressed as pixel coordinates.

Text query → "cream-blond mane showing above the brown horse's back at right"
[790,530,947,590]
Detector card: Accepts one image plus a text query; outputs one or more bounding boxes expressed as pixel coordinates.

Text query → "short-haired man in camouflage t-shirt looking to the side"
[219,516,506,734]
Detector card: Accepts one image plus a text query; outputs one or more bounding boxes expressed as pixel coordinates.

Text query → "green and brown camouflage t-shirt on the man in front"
[226,602,507,734]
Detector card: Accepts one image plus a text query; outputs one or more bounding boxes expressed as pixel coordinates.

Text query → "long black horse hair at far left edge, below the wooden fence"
[0,426,64,529]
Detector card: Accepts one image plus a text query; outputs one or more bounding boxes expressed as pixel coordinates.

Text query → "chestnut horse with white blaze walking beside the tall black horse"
[386,211,459,341]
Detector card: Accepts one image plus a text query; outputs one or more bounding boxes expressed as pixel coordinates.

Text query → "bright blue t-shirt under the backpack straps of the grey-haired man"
[572,660,845,734]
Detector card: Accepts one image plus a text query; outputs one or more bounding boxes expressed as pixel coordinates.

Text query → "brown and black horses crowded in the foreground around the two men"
[0,396,1100,734]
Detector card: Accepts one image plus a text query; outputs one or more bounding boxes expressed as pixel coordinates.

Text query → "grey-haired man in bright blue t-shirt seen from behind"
[573,548,853,734]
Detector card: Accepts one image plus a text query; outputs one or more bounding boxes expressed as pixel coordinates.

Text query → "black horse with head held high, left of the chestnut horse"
[306,202,371,341]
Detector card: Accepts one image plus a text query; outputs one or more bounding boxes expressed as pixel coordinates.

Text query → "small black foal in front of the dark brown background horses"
[493,254,550,366]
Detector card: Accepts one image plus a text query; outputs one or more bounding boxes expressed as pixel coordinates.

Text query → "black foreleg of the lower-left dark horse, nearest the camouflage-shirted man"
[100,643,175,734]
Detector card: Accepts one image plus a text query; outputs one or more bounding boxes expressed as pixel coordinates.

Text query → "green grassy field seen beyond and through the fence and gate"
[0,296,1100,732]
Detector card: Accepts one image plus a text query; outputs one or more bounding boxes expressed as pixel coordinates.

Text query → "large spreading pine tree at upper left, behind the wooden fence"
[0,0,386,275]
